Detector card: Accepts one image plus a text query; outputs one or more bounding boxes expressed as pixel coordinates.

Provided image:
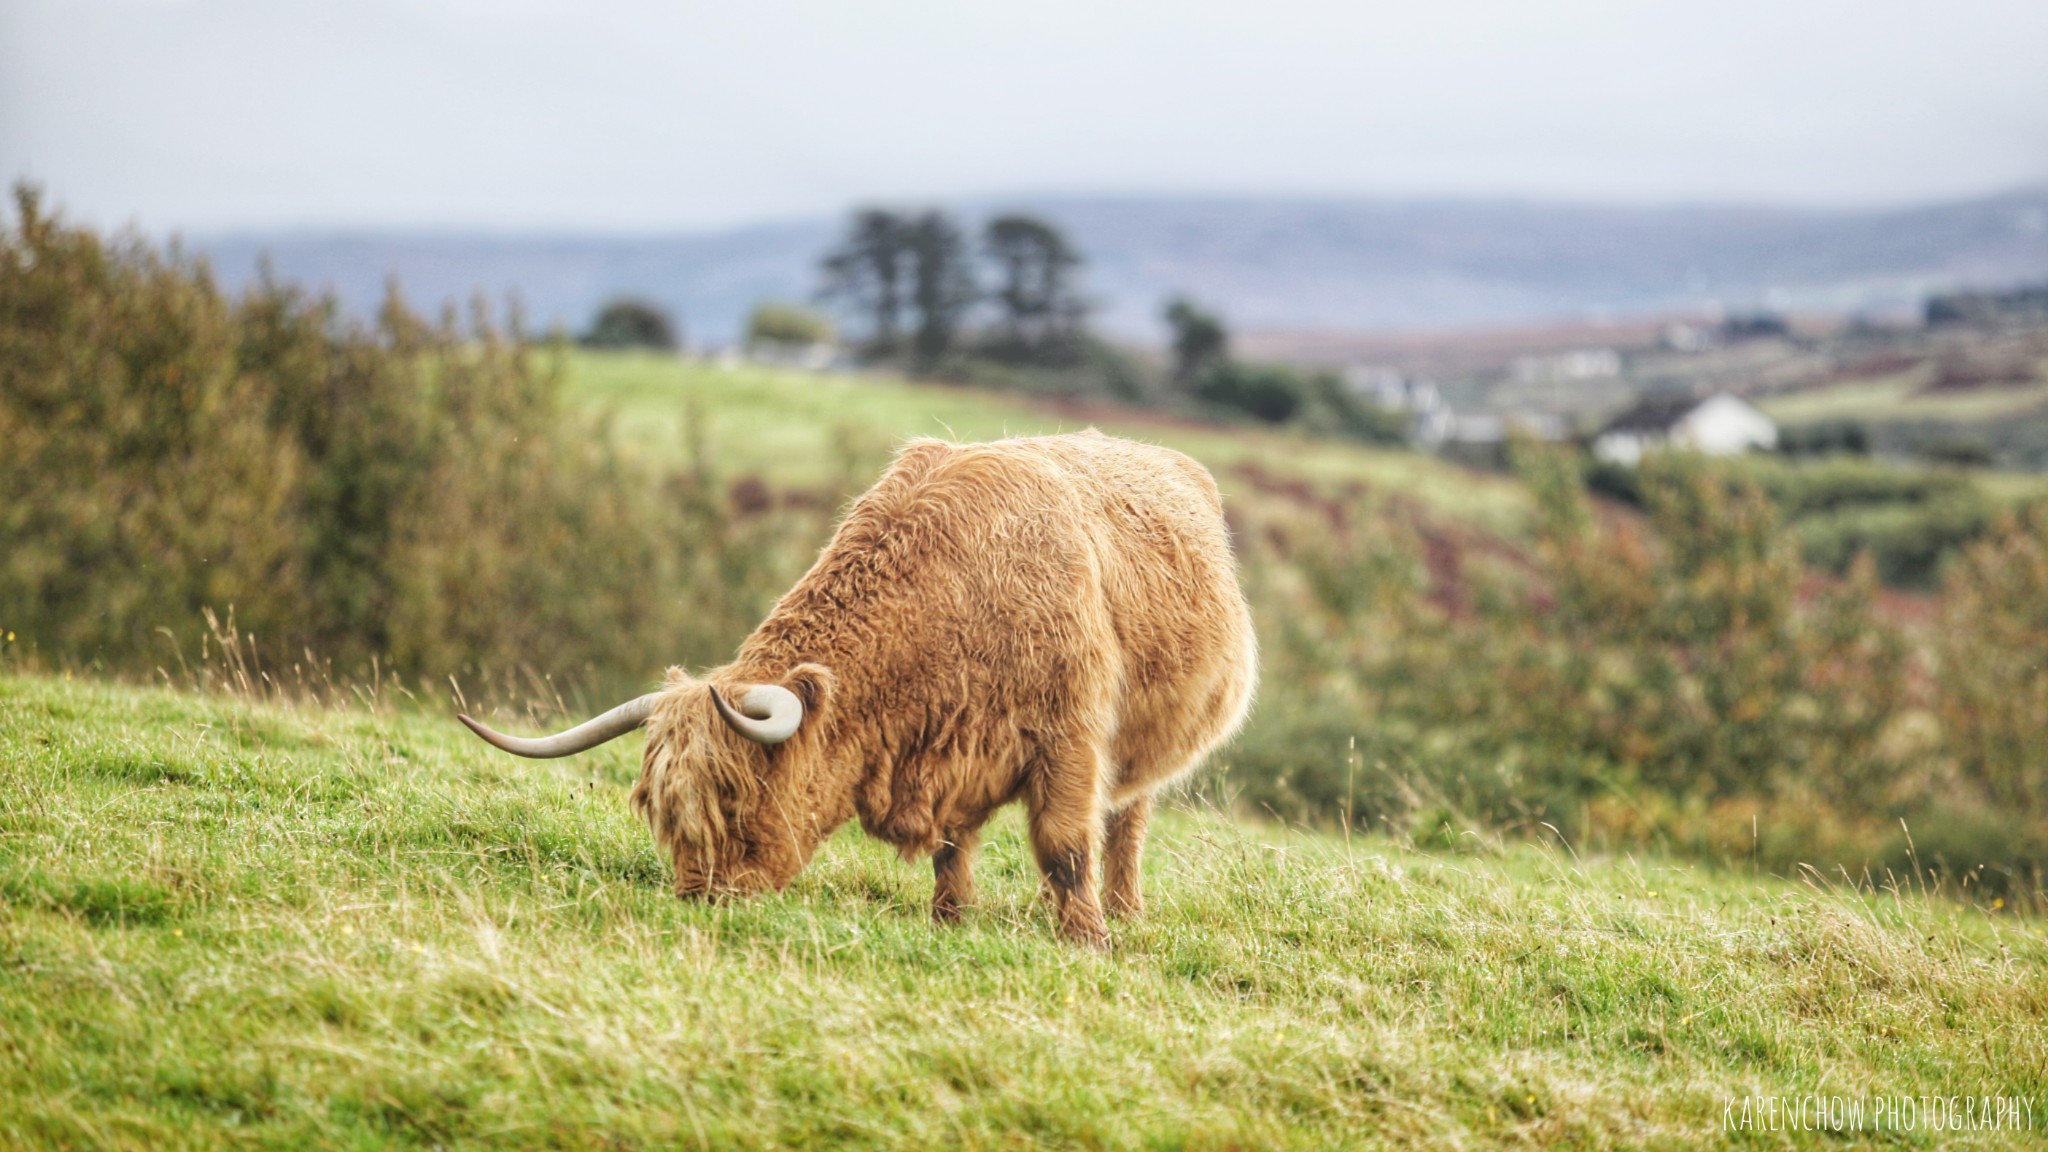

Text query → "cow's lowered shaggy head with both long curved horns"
[461,664,852,896]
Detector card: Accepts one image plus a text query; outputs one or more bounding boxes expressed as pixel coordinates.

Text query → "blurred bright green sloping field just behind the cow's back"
[565,351,1528,533]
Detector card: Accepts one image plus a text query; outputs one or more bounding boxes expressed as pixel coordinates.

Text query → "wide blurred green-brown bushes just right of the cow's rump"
[1233,447,1907,832]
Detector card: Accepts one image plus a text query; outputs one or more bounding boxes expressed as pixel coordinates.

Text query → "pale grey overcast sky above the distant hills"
[0,0,2048,232]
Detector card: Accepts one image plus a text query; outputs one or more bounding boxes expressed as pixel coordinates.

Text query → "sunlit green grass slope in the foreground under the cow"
[0,676,2048,1148]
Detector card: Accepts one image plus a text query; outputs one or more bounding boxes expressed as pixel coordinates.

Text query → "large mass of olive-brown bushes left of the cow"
[0,189,817,685]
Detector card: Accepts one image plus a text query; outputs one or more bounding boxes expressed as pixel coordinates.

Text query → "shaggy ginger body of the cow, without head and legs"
[741,430,1255,815]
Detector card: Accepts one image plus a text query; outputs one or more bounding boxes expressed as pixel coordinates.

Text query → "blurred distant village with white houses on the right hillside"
[1311,287,2048,467]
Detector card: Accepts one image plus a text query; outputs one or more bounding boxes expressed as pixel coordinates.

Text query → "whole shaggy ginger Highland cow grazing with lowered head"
[463,430,1257,947]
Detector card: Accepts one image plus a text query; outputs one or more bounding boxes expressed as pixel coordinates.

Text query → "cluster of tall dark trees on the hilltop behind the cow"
[821,209,1087,369]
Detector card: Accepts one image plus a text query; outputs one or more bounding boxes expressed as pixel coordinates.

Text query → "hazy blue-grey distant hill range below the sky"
[188,189,2048,342]
